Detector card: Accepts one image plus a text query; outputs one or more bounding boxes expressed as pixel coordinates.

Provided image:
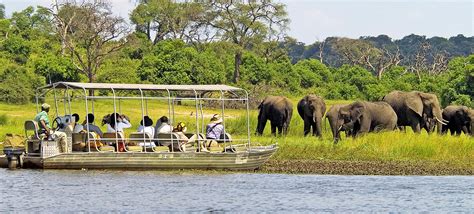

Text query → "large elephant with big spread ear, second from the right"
[383,91,446,133]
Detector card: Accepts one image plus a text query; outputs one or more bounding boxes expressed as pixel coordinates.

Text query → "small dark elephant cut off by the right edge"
[442,105,474,136]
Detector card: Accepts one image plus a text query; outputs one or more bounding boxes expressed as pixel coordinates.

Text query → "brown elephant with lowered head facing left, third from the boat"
[338,101,398,137]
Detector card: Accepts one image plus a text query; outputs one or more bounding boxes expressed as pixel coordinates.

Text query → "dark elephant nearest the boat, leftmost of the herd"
[256,96,293,135]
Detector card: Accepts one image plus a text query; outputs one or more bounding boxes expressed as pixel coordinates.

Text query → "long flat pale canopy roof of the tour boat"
[39,82,243,91]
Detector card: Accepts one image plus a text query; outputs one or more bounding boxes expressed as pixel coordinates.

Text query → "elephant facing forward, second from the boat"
[297,95,326,137]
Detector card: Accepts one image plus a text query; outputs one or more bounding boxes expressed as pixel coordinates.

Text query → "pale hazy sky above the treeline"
[0,0,474,44]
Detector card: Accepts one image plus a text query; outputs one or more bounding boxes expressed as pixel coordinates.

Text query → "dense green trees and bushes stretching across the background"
[0,0,474,107]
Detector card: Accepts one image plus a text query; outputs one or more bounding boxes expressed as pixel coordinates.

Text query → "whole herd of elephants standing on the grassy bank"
[256,91,474,142]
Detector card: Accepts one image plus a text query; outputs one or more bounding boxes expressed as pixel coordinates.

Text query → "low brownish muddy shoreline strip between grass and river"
[258,159,474,176]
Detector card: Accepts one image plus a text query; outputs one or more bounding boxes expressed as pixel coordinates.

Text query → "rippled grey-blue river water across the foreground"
[0,169,474,213]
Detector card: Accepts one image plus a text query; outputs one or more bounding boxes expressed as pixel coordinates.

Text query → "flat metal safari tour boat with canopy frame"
[3,82,278,170]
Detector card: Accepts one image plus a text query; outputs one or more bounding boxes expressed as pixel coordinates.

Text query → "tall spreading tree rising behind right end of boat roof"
[206,0,288,82]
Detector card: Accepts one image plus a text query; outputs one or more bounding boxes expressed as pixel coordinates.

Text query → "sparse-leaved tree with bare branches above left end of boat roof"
[50,0,128,86]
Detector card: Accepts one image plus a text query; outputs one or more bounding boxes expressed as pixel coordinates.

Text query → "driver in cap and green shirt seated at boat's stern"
[34,103,67,152]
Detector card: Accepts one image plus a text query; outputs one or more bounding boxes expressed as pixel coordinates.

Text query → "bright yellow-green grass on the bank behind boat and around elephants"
[0,99,474,165]
